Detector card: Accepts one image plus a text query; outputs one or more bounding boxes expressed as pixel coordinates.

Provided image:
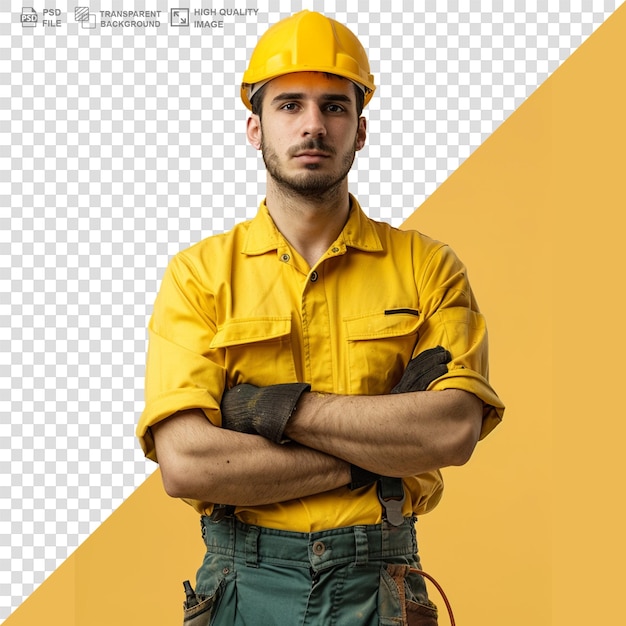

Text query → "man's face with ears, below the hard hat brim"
[248,72,366,197]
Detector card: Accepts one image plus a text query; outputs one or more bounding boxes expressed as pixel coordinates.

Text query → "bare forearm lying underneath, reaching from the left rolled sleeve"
[153,411,350,506]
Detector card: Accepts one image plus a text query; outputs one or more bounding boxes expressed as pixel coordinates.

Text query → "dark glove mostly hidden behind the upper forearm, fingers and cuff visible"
[349,346,452,489]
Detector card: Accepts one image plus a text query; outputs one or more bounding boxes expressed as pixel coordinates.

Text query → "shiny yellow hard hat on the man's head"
[241,11,376,109]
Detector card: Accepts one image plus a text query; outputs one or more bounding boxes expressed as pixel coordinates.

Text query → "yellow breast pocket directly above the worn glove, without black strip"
[211,317,297,388]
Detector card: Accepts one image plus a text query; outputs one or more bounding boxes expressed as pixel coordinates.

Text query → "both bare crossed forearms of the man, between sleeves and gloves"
[152,389,483,506]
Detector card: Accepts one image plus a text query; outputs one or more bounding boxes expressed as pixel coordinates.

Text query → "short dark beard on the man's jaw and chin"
[261,135,357,199]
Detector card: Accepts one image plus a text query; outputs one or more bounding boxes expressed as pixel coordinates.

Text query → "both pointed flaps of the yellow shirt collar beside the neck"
[242,194,383,256]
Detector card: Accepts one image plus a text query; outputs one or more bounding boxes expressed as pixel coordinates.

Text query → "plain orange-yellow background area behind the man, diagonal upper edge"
[5,5,626,626]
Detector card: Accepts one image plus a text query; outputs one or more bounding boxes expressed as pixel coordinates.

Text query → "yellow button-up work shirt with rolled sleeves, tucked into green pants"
[137,196,504,532]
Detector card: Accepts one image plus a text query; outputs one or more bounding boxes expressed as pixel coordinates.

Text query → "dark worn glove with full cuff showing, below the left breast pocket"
[222,383,311,443]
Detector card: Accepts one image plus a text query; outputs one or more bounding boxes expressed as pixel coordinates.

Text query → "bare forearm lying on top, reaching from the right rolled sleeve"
[285,390,482,477]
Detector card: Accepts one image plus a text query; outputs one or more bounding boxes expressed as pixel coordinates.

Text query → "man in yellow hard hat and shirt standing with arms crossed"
[138,11,503,626]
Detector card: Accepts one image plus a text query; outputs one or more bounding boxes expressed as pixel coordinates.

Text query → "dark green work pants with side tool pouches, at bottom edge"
[185,516,437,626]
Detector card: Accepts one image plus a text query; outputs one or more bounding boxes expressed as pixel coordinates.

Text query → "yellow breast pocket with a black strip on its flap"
[344,309,421,395]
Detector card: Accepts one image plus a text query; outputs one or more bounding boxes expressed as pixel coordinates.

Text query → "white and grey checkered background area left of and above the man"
[0,0,619,621]
